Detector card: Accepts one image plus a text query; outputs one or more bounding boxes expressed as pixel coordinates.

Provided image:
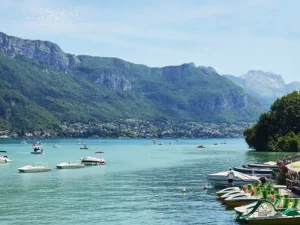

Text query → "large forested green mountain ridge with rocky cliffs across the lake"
[0,32,268,130]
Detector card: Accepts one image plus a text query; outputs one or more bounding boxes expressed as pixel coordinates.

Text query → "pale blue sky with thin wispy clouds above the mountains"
[0,0,300,83]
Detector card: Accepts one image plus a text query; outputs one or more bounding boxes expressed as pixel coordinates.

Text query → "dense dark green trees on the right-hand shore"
[244,91,300,152]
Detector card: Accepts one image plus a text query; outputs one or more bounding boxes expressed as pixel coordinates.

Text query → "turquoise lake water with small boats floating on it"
[0,139,280,225]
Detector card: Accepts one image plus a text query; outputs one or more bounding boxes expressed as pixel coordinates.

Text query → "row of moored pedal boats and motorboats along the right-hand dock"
[208,163,300,225]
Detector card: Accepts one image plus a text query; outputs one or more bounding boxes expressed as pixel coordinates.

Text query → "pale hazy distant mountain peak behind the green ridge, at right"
[224,70,300,107]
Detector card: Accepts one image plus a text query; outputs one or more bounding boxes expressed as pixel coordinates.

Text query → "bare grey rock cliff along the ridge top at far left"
[0,32,80,70]
